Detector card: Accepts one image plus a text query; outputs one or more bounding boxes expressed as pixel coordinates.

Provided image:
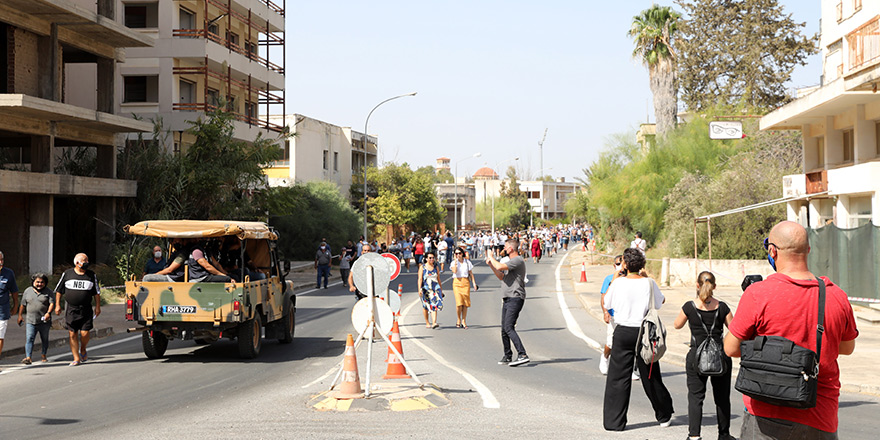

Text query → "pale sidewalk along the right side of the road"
[567,250,880,396]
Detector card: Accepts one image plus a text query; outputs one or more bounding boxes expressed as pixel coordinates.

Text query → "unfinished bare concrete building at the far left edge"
[0,0,153,274]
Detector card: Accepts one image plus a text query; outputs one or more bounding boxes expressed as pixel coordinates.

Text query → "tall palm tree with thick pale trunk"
[627,4,681,137]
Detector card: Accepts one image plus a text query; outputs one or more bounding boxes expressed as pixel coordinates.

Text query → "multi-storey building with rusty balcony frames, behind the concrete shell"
[73,0,286,151]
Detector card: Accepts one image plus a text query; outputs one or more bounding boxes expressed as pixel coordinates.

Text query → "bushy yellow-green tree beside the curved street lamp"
[360,163,446,229]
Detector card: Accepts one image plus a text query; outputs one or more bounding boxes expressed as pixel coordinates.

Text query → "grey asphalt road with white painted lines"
[0,249,880,439]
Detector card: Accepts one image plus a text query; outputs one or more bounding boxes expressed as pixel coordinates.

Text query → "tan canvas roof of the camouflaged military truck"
[124,220,278,240]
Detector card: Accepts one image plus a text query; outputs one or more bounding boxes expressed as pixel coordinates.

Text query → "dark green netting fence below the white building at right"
[807,223,880,302]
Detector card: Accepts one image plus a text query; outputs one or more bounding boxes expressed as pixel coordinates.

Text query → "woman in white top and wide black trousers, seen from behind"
[602,248,673,431]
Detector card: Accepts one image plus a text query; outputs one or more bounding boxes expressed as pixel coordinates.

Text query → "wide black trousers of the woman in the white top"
[602,325,673,431]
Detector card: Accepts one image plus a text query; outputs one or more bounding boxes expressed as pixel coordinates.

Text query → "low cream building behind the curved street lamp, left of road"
[264,114,378,199]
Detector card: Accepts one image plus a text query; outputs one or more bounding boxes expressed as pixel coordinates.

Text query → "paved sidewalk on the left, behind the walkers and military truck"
[0,261,324,365]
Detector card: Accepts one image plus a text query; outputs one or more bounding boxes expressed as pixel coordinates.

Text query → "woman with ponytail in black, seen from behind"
[674,271,733,440]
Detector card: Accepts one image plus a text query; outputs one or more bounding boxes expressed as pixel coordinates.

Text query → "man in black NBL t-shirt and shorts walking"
[55,254,101,367]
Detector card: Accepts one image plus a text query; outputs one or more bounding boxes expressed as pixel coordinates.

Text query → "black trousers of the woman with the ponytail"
[685,348,733,437]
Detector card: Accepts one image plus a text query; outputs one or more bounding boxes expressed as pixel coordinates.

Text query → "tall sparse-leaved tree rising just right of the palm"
[672,0,817,111]
